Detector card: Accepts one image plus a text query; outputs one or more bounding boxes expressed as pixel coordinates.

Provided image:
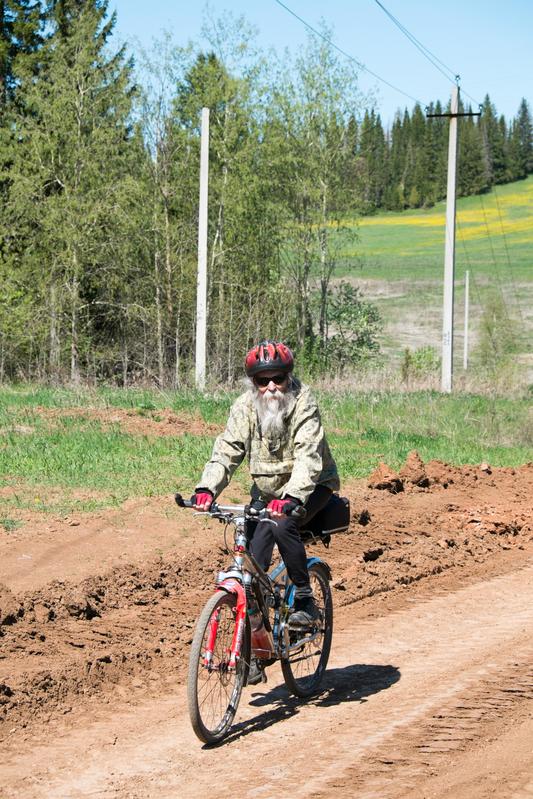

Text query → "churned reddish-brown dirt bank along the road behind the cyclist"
[0,462,533,732]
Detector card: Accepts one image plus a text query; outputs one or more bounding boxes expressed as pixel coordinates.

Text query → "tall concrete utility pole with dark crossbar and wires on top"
[427,86,480,393]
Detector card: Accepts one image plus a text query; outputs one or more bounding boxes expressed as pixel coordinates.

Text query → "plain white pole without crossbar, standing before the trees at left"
[196,108,209,391]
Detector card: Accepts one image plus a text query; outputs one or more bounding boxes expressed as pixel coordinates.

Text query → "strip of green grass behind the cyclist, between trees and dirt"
[0,386,533,512]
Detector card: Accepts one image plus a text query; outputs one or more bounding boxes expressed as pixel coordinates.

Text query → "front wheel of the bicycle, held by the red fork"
[187,591,250,744]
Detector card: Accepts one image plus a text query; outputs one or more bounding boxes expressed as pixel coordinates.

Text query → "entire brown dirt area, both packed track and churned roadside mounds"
[0,465,533,799]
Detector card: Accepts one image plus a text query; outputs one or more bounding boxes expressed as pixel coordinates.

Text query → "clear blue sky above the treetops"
[109,0,533,124]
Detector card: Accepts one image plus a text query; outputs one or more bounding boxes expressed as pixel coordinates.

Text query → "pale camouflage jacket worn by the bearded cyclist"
[197,385,339,502]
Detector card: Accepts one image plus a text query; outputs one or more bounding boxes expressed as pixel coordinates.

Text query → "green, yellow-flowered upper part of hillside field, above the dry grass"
[334,176,533,282]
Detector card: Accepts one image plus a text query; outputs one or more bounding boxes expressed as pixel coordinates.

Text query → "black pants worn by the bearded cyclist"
[248,486,331,588]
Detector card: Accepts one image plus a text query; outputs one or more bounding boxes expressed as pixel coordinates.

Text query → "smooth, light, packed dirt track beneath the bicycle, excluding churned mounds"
[4,561,533,799]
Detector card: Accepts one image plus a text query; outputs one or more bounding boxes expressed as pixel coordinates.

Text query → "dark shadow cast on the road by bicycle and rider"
[203,664,401,748]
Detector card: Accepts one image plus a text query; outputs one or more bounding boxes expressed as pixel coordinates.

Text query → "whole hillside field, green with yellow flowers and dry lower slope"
[333,176,533,370]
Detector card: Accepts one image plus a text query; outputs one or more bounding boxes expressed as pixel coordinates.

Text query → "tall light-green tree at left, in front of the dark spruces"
[4,3,136,382]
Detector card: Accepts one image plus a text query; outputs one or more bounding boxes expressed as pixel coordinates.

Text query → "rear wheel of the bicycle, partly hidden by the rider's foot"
[281,563,333,698]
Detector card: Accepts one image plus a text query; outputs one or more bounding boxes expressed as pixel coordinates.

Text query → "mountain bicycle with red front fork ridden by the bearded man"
[176,494,333,744]
